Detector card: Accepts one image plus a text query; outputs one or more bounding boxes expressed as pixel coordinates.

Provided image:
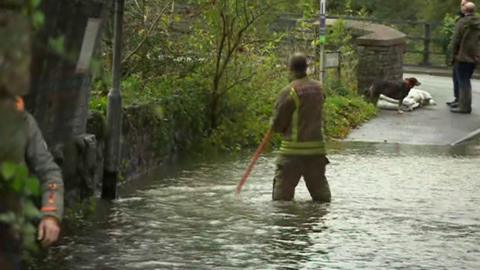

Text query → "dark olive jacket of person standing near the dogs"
[452,15,480,64]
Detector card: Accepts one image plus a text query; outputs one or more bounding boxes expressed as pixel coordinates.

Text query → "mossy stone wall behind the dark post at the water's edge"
[87,104,176,191]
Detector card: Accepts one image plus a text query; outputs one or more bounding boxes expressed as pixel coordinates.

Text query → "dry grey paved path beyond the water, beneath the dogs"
[346,74,480,145]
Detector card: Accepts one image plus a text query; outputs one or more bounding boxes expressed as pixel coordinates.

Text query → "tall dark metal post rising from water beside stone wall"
[102,0,124,200]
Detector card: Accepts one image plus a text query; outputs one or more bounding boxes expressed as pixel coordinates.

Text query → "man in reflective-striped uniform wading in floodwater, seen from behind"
[272,53,331,202]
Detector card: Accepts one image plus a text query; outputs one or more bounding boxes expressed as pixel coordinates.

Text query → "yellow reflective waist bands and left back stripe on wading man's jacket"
[279,87,326,156]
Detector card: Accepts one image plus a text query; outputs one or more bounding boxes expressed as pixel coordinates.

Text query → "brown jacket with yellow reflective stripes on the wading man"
[272,77,325,155]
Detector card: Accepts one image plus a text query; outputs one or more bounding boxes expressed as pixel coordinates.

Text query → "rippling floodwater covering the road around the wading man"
[35,142,480,270]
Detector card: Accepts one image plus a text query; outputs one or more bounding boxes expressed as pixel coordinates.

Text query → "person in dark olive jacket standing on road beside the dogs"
[450,2,480,114]
